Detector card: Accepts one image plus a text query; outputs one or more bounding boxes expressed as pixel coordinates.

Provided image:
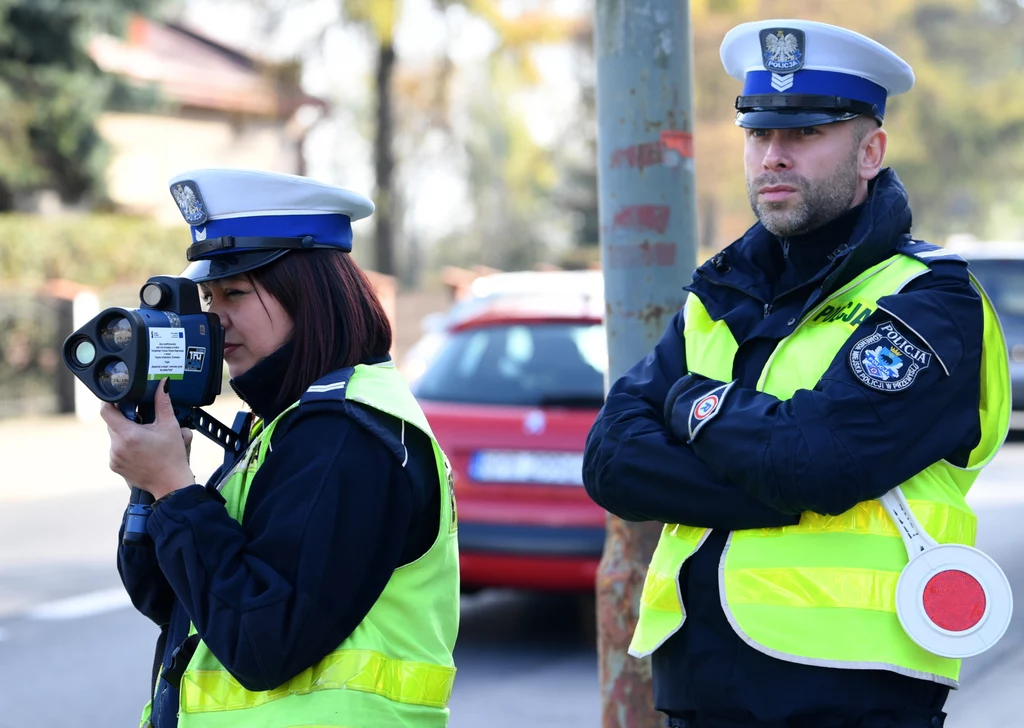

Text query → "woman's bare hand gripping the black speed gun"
[100,379,196,499]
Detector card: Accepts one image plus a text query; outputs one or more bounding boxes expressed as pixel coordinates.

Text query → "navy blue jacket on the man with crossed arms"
[584,170,982,728]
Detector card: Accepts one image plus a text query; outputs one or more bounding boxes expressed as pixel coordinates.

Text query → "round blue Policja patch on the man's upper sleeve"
[850,322,934,392]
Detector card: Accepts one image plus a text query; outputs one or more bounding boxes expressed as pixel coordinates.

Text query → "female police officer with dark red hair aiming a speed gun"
[103,169,459,728]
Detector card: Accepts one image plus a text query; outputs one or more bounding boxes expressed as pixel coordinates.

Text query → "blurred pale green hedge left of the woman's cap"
[0,214,190,288]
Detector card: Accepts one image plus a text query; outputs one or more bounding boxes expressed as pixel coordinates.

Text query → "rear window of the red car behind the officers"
[413,323,607,409]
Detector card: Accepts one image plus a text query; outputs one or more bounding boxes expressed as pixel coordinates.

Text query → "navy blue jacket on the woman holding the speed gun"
[118,345,440,728]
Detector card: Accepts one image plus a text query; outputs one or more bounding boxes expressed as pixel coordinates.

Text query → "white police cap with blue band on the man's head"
[721,19,913,129]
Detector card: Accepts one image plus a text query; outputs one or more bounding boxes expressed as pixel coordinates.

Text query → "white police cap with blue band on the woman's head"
[170,169,374,283]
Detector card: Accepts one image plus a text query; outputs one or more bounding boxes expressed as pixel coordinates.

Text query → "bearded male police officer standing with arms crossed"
[584,20,1009,728]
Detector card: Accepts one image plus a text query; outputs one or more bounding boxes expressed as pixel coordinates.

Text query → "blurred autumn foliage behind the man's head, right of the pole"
[692,0,1024,248]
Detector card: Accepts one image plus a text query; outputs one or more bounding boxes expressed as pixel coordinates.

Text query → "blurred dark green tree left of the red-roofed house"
[0,0,157,211]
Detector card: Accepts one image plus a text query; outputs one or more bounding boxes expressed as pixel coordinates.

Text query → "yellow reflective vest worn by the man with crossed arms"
[630,247,1010,687]
